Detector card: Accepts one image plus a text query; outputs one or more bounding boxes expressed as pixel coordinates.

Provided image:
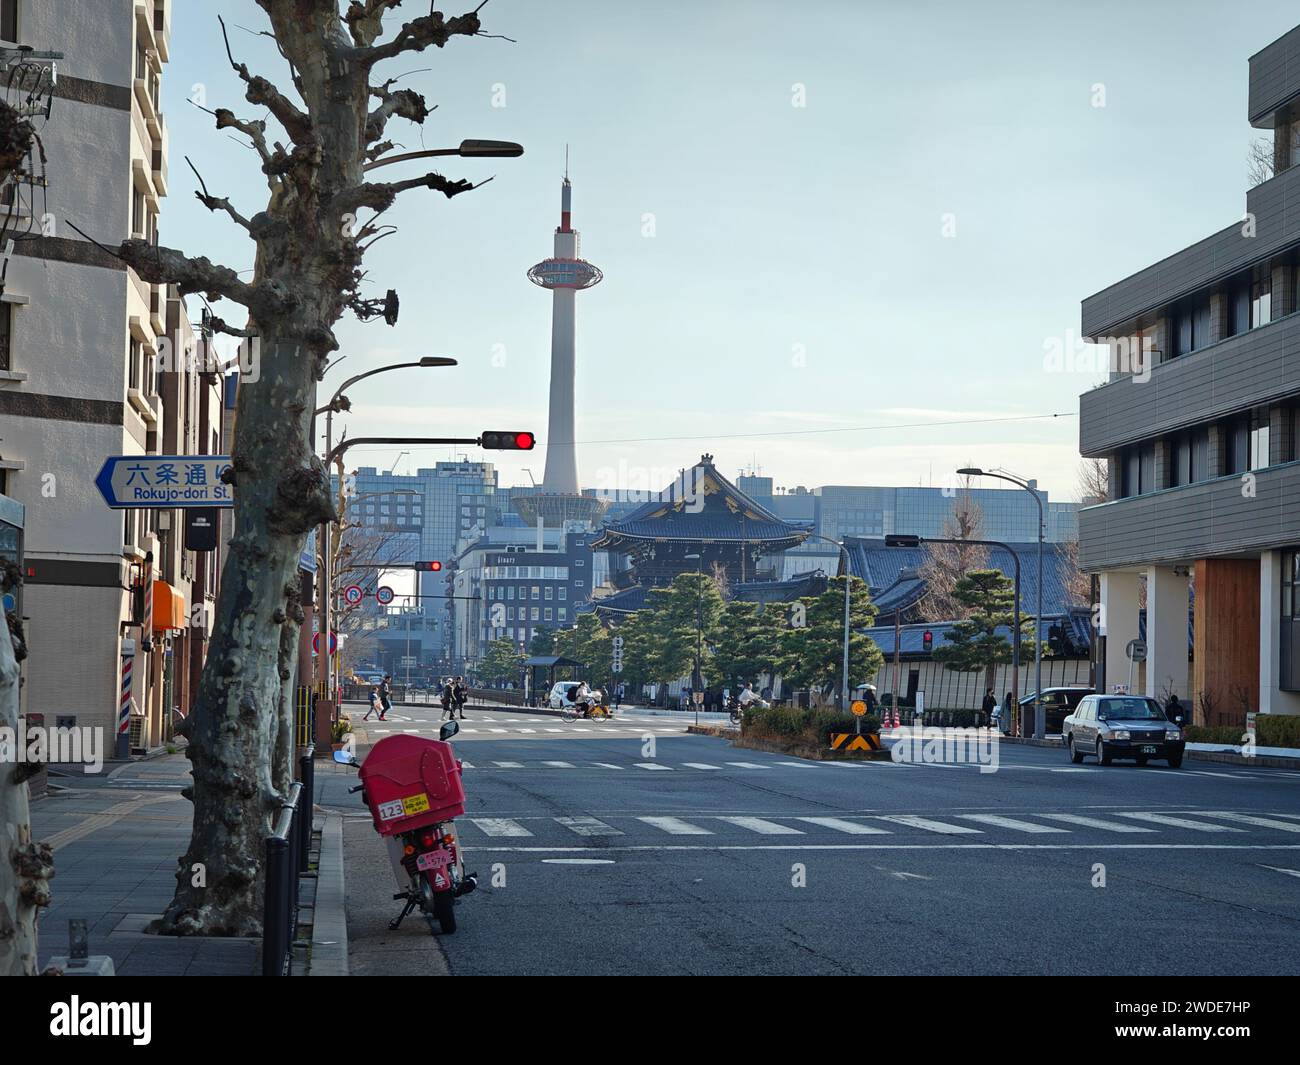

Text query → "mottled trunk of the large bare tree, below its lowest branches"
[159,341,329,935]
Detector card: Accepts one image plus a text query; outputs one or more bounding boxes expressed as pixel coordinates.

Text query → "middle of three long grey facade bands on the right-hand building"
[1079,313,1300,458]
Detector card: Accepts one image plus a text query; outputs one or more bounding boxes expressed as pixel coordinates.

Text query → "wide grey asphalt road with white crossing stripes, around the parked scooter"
[321,707,1300,975]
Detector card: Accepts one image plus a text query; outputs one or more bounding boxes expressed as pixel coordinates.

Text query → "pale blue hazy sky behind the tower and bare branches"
[160,0,1296,499]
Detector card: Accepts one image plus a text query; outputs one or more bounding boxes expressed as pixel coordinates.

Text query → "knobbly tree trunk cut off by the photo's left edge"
[0,574,55,977]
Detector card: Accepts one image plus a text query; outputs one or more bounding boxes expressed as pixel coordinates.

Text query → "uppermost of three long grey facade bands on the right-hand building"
[1083,152,1300,337]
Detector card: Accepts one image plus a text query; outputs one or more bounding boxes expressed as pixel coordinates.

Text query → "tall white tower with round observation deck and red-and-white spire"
[516,163,605,525]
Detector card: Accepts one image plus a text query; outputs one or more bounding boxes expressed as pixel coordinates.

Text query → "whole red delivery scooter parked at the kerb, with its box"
[334,720,478,935]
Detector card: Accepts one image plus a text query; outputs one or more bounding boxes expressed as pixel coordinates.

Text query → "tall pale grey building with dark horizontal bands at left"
[0,0,202,745]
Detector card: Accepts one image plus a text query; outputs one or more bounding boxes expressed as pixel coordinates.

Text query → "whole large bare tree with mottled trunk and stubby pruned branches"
[109,0,504,935]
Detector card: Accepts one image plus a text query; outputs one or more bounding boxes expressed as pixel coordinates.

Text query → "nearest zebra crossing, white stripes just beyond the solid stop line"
[458,809,1300,847]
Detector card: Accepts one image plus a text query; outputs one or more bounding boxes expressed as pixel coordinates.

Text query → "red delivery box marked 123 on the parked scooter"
[360,736,465,836]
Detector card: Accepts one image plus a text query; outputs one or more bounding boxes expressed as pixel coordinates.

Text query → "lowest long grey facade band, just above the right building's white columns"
[1079,462,1300,572]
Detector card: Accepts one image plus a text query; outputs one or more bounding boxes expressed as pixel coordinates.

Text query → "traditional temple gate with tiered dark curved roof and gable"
[592,455,811,592]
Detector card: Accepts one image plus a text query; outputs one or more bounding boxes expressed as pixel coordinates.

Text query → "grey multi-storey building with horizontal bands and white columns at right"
[1079,27,1300,726]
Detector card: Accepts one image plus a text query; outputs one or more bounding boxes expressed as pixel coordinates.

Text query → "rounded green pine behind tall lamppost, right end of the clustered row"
[780,577,884,690]
